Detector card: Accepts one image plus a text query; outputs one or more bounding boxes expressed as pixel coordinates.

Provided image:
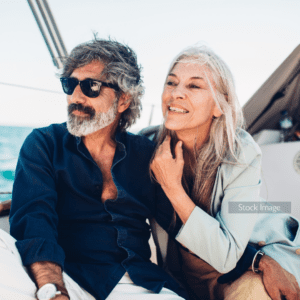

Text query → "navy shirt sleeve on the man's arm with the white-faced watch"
[10,130,65,267]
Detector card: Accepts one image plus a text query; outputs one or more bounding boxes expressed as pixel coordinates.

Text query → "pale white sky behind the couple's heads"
[0,0,300,130]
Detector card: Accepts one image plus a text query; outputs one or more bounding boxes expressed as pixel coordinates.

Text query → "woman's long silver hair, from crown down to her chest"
[158,46,244,211]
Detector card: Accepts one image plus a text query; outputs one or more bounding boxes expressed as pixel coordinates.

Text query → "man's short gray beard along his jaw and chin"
[67,99,118,137]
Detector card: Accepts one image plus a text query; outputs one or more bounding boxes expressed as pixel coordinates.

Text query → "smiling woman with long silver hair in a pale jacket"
[151,47,300,300]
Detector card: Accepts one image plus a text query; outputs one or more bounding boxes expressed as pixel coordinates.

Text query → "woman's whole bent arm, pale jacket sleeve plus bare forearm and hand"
[151,139,261,273]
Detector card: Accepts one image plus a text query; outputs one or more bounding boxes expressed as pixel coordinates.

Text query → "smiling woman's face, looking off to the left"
[162,62,221,134]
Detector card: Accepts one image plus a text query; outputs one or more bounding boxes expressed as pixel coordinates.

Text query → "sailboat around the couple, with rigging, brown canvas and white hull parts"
[0,0,300,241]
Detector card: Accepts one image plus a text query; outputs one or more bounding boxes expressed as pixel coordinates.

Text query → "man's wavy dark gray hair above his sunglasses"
[61,35,144,130]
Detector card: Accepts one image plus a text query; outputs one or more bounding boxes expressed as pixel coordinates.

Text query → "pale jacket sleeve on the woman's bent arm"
[176,145,261,273]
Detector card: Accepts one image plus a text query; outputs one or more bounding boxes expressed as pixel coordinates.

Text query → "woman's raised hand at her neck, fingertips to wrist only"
[150,135,184,194]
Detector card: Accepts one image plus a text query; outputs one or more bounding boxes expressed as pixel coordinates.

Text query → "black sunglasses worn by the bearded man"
[60,77,120,98]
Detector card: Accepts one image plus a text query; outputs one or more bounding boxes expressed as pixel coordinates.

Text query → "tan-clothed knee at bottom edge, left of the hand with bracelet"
[224,271,271,300]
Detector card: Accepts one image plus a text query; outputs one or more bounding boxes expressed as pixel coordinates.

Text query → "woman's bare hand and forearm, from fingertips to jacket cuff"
[150,136,195,224]
